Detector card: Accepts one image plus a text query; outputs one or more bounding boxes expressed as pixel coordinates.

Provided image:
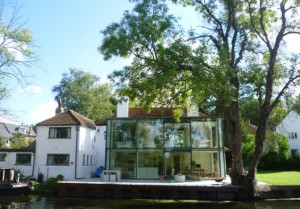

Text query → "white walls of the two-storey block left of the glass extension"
[34,125,97,180]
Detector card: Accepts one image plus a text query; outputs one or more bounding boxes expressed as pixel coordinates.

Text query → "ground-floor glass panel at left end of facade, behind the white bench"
[110,149,136,179]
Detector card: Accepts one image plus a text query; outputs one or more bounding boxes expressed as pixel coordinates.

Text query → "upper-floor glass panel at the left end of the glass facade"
[112,120,136,149]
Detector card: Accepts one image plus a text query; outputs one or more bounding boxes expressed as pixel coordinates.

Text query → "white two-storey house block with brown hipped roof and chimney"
[34,108,99,179]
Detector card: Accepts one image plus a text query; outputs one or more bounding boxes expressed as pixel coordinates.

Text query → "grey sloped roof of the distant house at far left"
[0,123,36,139]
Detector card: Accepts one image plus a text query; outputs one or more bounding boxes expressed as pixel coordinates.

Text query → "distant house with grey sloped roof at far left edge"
[0,122,36,147]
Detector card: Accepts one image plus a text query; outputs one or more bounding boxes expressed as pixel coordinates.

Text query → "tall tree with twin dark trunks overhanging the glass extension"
[99,0,298,199]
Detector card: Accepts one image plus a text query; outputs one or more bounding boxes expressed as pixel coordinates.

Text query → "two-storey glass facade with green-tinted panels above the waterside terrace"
[105,118,225,179]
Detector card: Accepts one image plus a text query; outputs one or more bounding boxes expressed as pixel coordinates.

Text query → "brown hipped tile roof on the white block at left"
[36,109,96,129]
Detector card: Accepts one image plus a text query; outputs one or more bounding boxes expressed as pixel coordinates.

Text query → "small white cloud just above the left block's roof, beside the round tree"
[27,101,57,124]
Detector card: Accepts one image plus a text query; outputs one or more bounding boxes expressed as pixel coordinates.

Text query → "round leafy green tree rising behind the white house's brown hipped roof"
[52,69,115,121]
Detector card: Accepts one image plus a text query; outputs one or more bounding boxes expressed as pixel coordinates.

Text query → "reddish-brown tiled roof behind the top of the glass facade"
[96,108,205,125]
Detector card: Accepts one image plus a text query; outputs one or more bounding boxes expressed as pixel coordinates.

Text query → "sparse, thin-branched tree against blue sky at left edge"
[0,0,37,115]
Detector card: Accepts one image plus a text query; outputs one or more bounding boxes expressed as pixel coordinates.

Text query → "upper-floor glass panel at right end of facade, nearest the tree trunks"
[191,121,218,148]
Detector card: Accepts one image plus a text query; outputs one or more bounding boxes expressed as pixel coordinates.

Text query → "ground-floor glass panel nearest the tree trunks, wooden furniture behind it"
[192,151,223,179]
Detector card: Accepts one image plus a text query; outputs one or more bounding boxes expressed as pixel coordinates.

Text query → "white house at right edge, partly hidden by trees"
[276,111,300,153]
